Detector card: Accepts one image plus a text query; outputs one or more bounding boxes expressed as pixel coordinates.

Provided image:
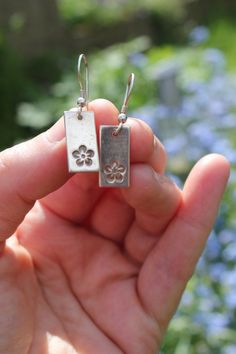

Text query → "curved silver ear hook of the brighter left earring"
[77,54,89,119]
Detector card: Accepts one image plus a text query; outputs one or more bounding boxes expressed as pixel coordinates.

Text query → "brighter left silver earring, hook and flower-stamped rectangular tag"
[64,54,99,172]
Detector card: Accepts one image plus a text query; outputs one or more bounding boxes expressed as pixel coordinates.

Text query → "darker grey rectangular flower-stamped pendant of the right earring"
[99,125,130,188]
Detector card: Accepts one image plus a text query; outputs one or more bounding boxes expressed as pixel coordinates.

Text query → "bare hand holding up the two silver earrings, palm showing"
[0,100,229,354]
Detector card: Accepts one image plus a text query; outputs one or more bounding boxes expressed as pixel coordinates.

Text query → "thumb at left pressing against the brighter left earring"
[0,123,69,241]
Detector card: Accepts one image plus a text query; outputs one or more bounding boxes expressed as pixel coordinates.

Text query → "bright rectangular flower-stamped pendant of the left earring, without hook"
[64,111,99,172]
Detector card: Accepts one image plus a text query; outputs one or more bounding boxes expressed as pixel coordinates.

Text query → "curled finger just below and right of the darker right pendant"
[123,164,182,263]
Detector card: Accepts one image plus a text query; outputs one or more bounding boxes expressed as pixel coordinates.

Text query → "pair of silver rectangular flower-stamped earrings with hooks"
[64,54,134,187]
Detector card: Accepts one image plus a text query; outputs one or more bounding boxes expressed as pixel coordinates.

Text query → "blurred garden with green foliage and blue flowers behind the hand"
[0,0,236,354]
